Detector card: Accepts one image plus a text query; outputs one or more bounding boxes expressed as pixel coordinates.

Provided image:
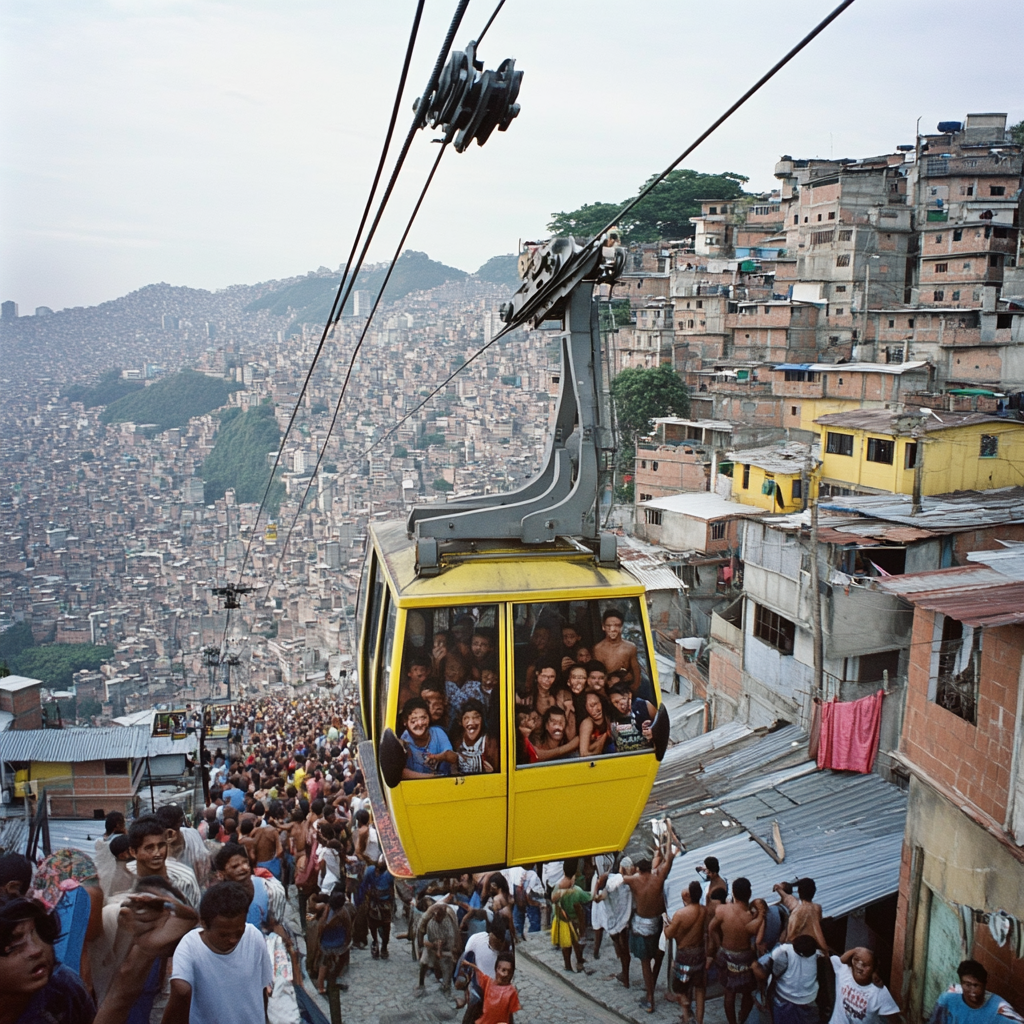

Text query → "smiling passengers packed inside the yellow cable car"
[396,607,657,779]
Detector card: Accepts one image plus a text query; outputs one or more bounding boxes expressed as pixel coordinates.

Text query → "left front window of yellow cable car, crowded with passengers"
[395,604,503,779]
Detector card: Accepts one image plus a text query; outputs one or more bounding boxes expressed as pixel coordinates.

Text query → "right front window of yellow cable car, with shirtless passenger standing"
[513,597,656,767]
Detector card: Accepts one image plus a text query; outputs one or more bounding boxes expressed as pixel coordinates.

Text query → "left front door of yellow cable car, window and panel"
[384,604,508,874]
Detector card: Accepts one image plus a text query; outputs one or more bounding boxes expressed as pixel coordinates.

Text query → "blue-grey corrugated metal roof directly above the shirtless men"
[667,771,906,918]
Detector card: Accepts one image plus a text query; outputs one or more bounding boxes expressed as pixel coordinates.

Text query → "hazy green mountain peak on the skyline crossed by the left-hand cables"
[246,249,469,332]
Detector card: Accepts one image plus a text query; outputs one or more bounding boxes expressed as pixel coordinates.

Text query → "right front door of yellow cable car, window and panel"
[507,597,657,864]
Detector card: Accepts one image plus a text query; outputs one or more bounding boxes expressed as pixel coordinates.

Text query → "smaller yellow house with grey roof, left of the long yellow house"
[722,441,818,512]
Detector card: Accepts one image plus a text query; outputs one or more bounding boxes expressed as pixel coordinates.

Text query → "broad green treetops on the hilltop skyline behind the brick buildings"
[548,170,746,242]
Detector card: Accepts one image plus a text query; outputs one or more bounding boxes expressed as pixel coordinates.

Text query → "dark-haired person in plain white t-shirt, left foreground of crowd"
[163,882,273,1024]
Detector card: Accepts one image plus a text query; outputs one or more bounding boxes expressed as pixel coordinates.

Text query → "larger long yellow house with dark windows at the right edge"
[815,409,1024,495]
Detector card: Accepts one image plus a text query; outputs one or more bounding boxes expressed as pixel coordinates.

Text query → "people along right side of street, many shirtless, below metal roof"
[551,820,1024,1024]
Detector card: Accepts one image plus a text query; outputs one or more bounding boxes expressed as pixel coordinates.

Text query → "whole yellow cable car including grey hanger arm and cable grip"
[359,220,669,877]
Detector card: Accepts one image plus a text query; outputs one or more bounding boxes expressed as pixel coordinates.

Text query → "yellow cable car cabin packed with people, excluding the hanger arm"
[359,522,669,877]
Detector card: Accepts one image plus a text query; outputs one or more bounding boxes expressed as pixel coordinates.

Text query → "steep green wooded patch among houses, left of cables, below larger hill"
[200,404,285,516]
